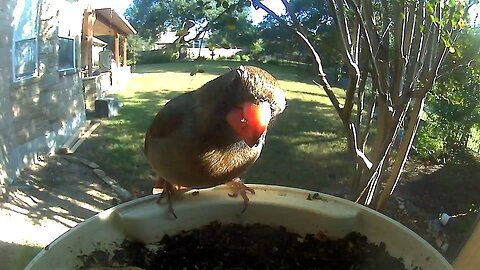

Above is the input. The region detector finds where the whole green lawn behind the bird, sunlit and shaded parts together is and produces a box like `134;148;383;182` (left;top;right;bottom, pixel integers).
78;61;353;193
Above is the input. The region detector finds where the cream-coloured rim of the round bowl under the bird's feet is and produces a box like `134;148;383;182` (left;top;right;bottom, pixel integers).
26;185;452;270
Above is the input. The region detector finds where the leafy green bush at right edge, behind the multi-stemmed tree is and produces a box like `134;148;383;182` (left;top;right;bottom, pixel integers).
417;29;480;157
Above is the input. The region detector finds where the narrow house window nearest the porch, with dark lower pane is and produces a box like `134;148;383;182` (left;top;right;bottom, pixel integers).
58;1;78;71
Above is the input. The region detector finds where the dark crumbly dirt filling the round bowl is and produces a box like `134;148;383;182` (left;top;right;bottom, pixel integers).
79;222;420;270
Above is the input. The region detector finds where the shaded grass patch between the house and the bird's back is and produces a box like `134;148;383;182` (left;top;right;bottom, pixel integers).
76;90;182;196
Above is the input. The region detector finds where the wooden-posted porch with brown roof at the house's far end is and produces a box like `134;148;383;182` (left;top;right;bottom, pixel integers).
81;8;137;110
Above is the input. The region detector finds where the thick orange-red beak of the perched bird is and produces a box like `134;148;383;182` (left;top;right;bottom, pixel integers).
226;102;272;147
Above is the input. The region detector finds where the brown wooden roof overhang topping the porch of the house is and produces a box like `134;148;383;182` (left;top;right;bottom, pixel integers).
93;8;137;36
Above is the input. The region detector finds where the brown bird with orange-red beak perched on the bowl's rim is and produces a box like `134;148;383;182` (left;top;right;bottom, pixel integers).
144;65;287;218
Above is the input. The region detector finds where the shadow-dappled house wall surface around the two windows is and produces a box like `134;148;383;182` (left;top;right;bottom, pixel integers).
0;0;85;190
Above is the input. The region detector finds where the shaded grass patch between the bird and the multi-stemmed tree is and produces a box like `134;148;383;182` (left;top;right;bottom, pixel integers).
245;99;352;191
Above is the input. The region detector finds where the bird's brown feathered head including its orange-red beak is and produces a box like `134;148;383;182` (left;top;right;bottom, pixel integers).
226;66;287;147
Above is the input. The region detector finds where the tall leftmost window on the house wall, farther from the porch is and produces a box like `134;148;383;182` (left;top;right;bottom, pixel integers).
12;0;40;81
